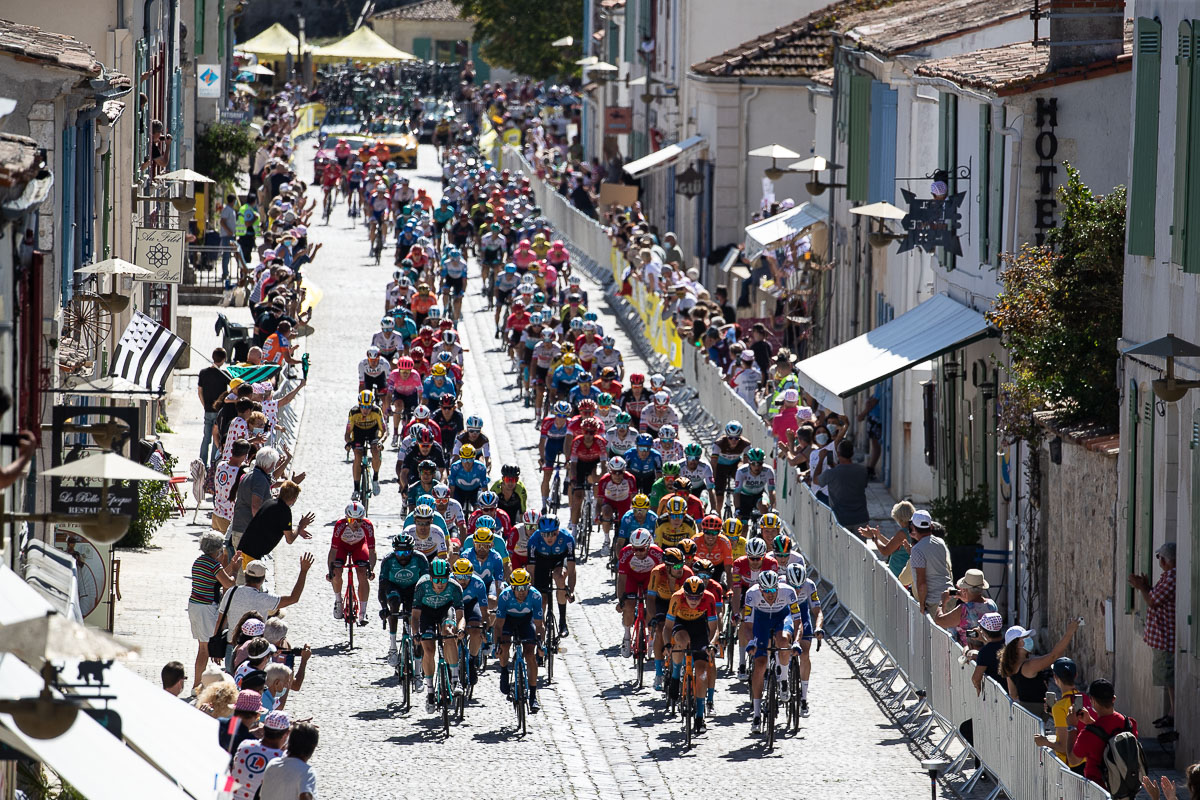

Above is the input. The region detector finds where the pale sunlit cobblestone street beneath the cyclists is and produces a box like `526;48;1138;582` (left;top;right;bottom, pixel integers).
116;145;945;800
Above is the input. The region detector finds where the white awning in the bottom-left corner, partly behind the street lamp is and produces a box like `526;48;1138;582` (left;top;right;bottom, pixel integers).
0;652;190;800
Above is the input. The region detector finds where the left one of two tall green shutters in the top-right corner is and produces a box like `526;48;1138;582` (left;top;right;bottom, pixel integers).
1128;17;1163;255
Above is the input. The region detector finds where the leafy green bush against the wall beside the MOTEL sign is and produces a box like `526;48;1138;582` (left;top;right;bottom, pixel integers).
988;164;1126;441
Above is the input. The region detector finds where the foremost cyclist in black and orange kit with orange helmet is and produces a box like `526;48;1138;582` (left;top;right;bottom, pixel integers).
665;575;721;734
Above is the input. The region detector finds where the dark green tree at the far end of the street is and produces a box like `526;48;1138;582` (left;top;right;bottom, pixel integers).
455;0;583;79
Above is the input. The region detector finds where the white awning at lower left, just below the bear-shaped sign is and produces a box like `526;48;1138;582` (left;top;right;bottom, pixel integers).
64;662;229;798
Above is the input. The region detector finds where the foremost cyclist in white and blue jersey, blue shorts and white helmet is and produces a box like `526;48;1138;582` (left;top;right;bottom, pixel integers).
742;573;800;733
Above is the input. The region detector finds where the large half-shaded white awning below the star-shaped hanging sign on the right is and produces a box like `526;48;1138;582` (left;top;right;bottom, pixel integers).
796;294;991;414
